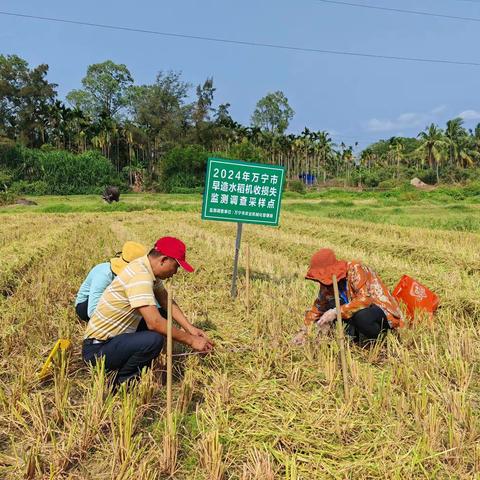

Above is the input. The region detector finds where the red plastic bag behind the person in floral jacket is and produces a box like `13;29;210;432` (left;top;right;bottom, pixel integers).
393;275;440;321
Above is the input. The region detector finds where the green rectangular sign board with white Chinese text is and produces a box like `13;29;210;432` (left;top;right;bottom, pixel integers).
202;158;285;225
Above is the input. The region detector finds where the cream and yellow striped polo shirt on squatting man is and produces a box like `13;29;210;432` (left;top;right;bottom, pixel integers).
84;255;162;340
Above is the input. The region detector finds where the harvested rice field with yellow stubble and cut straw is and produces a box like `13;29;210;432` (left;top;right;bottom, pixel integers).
0;196;480;480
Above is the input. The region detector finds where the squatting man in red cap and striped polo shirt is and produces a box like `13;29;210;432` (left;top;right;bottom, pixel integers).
82;237;213;384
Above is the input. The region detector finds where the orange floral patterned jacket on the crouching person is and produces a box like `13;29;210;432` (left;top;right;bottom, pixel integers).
305;262;403;328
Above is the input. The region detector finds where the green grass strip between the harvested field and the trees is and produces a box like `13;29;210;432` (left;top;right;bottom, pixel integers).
0;187;480;232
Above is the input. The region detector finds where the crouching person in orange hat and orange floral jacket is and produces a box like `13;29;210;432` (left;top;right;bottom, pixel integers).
293;248;403;345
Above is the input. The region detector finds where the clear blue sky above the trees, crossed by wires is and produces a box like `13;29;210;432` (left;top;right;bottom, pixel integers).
0;0;480;147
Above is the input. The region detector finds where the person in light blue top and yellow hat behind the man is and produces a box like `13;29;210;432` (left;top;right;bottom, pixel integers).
75;242;147;322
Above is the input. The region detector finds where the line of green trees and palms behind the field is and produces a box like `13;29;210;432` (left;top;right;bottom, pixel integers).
0;55;480;193
